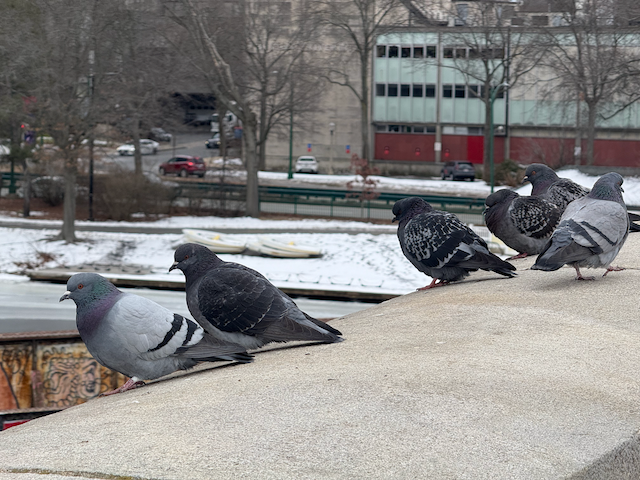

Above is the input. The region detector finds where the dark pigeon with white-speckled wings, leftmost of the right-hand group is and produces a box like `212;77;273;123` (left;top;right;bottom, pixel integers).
393;197;516;290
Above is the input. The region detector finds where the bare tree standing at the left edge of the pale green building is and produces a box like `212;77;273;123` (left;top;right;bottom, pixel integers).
313;0;403;159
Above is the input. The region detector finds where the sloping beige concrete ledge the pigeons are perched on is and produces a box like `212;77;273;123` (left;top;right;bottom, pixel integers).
0;234;640;479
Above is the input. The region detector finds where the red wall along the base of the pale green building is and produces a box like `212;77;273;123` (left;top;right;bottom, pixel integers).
374;133;640;168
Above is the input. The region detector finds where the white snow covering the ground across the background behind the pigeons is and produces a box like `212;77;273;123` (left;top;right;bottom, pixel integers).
0;170;640;294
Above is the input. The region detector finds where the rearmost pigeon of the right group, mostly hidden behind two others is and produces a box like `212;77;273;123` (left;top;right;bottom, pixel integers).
522;163;640;232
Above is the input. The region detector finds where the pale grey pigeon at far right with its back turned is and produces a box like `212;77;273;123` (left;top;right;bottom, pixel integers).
531;172;629;280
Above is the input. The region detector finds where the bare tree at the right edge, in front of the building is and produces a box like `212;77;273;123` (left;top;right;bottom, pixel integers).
540;0;640;165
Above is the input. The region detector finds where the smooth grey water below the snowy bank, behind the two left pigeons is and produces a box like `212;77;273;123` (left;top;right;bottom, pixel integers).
0;281;374;333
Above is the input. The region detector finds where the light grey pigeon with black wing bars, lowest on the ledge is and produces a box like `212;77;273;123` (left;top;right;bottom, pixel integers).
60;273;252;395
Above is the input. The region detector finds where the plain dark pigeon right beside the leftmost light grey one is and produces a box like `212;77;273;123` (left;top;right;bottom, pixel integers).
169;243;343;349
